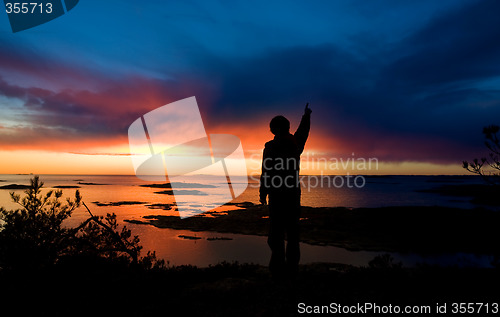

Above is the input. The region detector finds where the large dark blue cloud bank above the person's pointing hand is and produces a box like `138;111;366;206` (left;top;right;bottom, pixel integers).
188;1;500;162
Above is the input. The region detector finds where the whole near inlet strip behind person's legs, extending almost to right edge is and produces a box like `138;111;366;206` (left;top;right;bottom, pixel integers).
130;224;491;267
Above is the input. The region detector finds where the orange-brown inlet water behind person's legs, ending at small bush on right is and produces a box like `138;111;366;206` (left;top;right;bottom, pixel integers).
129;224;378;266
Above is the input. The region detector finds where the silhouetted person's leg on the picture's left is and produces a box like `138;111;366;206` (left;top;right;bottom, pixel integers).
267;197;286;278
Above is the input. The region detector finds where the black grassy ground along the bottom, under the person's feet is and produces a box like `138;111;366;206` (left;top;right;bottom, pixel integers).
0;258;500;317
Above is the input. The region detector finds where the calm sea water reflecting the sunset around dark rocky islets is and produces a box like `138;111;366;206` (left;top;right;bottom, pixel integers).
0;175;489;266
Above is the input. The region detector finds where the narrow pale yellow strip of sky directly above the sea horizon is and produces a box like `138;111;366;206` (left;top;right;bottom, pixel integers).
0;151;467;175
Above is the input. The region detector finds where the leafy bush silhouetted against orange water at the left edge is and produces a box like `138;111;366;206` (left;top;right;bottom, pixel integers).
0;176;164;269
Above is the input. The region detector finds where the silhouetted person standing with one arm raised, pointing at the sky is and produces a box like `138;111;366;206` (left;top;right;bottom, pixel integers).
260;104;312;279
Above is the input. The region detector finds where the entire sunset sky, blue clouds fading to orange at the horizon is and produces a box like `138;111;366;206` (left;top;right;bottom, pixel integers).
0;0;500;174
